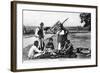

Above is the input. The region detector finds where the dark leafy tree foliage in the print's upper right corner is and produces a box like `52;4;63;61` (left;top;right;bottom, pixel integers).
80;13;91;31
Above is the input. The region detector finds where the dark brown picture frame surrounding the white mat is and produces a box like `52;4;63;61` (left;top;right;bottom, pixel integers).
11;1;98;72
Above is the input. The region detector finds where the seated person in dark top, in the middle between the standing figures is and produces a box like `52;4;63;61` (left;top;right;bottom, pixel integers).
45;38;55;55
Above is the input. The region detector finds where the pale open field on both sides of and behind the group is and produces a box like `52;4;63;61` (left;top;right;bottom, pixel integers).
23;32;91;60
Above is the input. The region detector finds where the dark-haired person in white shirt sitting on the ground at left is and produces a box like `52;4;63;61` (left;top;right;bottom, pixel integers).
28;41;42;59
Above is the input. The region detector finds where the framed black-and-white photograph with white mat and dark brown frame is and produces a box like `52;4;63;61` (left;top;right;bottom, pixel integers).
11;1;97;71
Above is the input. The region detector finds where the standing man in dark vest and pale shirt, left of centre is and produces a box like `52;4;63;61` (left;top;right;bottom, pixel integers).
38;22;45;51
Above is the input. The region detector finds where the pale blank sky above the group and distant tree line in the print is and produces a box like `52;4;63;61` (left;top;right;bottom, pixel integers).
23;10;84;27
